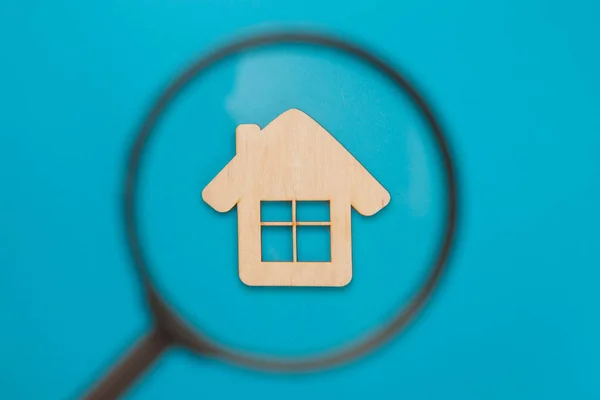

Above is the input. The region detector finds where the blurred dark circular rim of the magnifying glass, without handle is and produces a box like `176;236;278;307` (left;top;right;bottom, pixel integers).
123;32;458;372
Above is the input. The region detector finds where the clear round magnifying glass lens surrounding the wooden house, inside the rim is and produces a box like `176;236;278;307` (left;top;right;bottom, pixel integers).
137;46;447;357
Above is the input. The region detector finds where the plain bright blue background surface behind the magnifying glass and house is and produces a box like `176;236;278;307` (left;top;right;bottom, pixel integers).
0;0;600;400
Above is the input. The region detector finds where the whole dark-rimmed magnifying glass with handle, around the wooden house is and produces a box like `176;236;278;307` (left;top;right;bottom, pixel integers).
83;32;458;399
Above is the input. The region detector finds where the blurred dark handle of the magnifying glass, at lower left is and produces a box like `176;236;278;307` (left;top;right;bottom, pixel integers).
82;329;172;400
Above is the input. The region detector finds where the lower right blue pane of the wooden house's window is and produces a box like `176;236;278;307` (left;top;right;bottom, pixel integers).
296;226;331;262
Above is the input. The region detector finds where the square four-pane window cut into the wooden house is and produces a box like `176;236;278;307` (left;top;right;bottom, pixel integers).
260;200;331;262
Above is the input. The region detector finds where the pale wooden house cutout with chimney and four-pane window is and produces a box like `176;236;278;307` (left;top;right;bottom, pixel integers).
202;109;390;286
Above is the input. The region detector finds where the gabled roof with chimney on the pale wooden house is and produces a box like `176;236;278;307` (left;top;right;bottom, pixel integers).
202;109;390;215
